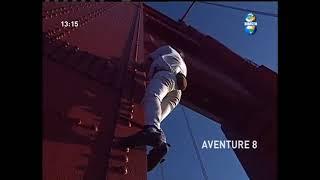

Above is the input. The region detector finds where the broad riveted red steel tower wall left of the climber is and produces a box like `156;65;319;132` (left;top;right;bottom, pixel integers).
43;2;146;180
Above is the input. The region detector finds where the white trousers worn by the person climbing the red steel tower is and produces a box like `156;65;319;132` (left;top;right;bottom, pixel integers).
143;71;181;129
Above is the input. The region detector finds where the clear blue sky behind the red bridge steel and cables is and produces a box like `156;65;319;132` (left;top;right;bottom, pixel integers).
147;2;278;180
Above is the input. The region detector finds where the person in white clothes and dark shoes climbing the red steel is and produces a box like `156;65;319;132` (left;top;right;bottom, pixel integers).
115;42;187;171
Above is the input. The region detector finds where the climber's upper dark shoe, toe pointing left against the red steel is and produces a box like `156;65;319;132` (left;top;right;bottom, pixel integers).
118;126;165;148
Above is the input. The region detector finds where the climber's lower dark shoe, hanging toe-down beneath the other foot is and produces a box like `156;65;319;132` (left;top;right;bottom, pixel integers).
147;143;170;172
